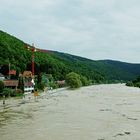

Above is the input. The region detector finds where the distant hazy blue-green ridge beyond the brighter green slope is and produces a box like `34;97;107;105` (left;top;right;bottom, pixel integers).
52;52;140;80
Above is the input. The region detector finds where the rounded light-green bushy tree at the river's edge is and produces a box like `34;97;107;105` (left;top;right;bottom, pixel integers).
66;72;82;88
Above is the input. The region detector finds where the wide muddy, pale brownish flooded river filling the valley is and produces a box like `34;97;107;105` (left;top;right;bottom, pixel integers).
0;84;140;140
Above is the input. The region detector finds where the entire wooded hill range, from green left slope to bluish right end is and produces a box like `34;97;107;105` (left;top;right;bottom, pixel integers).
0;31;140;83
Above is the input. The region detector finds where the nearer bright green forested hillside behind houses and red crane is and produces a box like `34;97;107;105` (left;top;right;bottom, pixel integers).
0;31;104;82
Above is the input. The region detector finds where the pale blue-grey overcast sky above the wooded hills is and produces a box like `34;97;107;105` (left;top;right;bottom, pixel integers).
0;0;140;63
